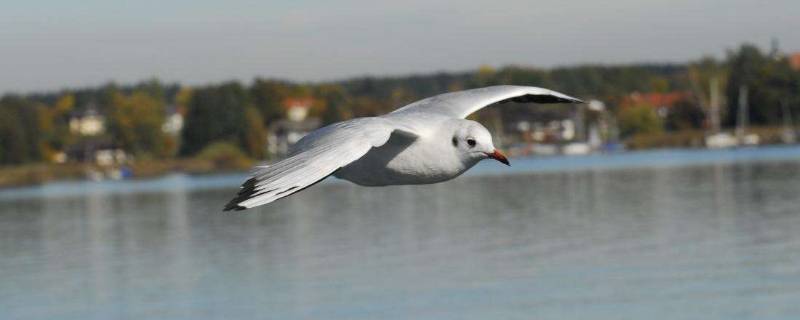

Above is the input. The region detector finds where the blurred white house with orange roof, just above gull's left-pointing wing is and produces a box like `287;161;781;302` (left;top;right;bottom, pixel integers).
267;98;322;155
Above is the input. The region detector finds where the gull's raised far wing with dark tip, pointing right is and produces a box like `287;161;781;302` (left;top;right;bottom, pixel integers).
392;86;583;118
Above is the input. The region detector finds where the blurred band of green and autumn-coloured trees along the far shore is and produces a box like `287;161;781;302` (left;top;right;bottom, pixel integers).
0;45;800;164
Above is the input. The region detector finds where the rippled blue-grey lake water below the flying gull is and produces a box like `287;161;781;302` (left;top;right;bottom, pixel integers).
0;147;800;320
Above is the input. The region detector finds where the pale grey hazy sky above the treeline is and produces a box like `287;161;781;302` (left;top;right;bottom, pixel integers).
0;0;800;93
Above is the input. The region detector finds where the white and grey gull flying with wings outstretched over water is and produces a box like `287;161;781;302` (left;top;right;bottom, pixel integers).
224;85;583;211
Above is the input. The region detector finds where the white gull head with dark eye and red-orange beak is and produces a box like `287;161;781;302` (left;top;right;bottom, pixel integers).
450;120;511;166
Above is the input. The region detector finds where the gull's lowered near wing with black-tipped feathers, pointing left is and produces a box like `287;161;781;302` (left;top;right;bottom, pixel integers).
224;118;413;211
